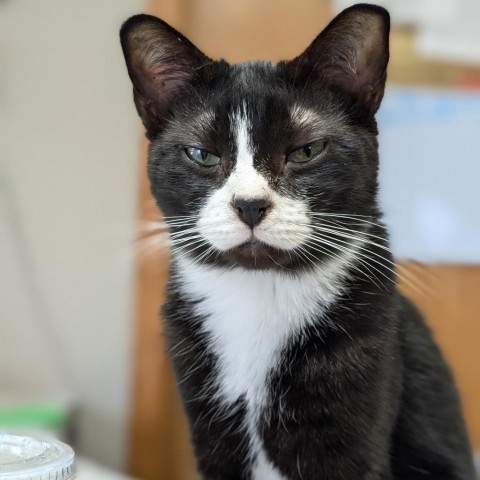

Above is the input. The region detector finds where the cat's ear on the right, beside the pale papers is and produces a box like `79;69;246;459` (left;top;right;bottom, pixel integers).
286;4;390;116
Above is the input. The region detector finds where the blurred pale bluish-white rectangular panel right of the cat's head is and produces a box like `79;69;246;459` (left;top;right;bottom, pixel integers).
377;87;480;264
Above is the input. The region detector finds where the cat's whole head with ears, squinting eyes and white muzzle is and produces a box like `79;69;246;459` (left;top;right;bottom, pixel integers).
121;5;389;269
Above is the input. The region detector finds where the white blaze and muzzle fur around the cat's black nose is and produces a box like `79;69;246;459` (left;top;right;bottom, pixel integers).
197;107;311;251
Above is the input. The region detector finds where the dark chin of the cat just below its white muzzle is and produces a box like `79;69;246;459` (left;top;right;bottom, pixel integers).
226;238;291;270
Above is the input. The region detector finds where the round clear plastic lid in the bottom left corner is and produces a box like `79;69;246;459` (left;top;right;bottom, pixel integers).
0;432;75;480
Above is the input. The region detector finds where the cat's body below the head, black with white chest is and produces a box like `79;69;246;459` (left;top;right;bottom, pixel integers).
165;263;473;480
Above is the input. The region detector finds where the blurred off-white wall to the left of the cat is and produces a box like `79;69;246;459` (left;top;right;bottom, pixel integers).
0;0;145;468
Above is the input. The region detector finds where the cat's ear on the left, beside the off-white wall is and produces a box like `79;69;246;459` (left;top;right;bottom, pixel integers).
120;15;212;140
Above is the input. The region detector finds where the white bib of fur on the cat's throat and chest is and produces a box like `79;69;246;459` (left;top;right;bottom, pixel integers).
177;249;355;480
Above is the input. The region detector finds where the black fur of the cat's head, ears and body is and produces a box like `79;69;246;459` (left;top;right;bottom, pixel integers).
121;5;474;480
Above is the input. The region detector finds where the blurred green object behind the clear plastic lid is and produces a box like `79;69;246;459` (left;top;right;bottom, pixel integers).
0;404;67;428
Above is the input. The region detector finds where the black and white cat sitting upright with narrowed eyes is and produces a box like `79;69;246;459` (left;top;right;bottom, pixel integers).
121;5;474;480
